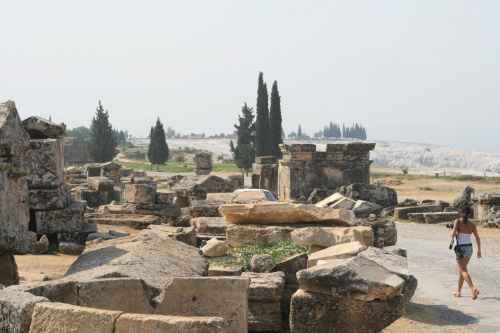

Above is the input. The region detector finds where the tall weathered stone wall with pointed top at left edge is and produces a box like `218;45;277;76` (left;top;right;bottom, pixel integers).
0;101;36;262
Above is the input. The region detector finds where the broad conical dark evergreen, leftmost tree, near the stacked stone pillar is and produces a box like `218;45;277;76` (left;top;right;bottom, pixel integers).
87;101;117;163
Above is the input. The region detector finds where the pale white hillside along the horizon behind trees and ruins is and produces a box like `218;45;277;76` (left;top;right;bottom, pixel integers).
130;139;500;173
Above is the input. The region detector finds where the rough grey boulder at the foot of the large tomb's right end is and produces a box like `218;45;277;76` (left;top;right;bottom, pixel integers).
339;183;398;208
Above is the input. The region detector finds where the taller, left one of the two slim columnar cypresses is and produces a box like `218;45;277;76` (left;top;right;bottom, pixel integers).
255;72;270;156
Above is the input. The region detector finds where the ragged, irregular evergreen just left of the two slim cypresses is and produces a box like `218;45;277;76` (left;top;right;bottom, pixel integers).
229;103;256;176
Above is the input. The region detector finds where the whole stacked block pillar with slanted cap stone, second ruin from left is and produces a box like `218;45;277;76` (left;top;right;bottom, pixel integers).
23;117;85;245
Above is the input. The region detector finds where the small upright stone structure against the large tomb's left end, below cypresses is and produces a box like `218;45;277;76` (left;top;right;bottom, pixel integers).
252;156;279;198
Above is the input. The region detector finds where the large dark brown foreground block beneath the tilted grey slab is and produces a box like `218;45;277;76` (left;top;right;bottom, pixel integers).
290;276;417;333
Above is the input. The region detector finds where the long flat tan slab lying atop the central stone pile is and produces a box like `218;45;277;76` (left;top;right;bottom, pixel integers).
219;202;353;226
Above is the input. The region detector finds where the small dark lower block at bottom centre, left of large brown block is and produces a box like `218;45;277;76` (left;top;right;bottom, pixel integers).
248;302;282;332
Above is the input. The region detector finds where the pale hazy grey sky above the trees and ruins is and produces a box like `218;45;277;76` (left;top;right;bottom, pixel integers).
0;0;500;152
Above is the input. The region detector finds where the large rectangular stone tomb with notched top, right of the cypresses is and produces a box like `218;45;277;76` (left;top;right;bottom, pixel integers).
278;142;375;201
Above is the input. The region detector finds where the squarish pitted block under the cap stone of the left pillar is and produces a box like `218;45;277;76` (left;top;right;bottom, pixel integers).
25;139;64;189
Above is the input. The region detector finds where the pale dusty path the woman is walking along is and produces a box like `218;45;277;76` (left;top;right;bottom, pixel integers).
384;223;500;333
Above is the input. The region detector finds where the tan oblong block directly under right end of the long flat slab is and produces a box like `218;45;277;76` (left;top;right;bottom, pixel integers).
292;227;373;247
